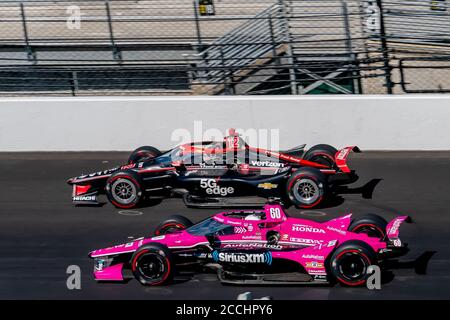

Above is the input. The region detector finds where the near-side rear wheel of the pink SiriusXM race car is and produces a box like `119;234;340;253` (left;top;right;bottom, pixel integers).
329;240;377;287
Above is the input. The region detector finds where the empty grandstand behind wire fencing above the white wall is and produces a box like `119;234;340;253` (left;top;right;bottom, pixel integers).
0;0;450;95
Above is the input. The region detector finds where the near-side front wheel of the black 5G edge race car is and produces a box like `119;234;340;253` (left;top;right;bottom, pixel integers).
105;170;143;209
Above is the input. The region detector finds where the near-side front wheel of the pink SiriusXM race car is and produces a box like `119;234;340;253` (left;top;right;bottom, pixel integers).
130;243;174;286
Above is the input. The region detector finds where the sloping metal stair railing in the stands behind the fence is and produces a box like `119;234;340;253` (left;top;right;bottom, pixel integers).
185;3;288;93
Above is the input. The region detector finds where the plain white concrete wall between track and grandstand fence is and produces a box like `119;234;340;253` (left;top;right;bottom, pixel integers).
0;95;450;151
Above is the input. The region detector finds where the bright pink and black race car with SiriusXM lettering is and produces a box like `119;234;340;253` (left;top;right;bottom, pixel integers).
89;201;409;286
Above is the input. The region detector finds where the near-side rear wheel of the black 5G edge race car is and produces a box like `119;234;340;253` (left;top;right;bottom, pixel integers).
286;167;328;209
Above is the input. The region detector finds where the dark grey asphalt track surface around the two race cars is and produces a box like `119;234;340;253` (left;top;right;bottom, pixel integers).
0;152;450;300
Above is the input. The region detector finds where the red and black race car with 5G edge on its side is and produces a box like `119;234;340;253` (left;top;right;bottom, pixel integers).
68;131;360;209
